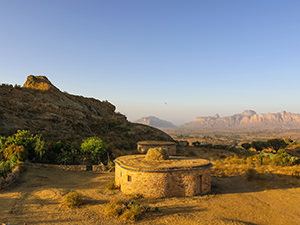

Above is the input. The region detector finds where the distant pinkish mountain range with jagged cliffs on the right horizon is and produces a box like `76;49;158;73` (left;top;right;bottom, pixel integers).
181;110;300;129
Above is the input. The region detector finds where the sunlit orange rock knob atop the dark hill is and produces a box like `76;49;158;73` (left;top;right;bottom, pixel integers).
23;75;58;91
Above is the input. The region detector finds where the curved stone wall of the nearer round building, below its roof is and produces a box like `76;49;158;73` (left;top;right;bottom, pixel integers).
115;163;211;198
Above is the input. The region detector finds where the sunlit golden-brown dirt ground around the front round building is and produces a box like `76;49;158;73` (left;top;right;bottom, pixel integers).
0;160;300;225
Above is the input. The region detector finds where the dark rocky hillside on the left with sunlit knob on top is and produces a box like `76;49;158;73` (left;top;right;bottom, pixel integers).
0;76;172;149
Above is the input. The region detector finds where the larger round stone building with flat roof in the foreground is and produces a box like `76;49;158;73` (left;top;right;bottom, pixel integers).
115;155;212;198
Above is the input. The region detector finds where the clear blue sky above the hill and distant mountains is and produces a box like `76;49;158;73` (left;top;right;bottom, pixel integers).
0;0;300;125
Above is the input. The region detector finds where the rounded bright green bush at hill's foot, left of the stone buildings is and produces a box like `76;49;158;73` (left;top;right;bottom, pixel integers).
81;137;106;163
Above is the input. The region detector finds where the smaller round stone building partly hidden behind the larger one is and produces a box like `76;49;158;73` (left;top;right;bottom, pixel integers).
137;141;176;155
